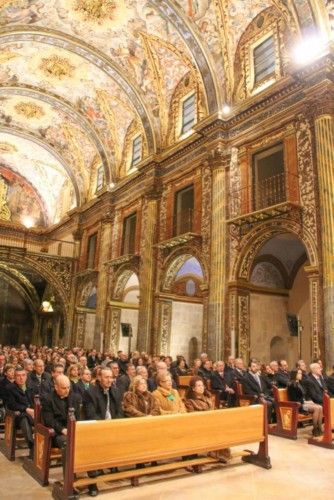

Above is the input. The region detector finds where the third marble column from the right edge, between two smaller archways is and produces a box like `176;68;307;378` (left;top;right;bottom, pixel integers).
137;197;158;352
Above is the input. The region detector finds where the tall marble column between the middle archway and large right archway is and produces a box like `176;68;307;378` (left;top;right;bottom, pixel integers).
207;145;230;360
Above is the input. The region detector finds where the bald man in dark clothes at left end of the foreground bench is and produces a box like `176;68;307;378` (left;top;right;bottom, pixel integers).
41;375;81;471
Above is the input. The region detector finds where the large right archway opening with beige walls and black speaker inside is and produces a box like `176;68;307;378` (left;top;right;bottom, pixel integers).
249;233;312;366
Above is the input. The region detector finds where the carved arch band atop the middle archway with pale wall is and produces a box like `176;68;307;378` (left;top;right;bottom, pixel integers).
159;248;208;292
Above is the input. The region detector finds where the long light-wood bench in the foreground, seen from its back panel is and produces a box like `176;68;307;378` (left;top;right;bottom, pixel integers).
52;403;271;500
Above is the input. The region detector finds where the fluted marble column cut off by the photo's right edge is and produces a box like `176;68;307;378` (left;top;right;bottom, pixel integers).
315;113;334;368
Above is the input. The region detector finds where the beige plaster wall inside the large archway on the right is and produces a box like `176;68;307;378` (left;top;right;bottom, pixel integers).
250;293;298;367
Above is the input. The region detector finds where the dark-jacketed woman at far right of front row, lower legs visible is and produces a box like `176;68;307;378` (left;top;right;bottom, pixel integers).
288;369;323;437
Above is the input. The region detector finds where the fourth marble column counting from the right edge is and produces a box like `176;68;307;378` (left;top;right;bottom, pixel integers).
94;218;112;350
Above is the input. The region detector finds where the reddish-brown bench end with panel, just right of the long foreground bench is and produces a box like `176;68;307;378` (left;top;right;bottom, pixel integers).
269;386;312;439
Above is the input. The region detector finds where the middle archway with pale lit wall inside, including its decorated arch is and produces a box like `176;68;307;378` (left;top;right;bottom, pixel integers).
159;255;204;361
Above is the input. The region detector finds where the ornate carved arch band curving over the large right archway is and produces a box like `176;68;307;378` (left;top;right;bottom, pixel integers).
231;220;319;281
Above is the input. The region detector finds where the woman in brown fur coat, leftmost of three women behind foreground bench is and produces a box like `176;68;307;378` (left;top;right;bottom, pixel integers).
122;375;160;417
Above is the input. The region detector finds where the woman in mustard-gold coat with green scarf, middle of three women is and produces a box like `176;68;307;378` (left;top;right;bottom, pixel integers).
152;372;186;415
